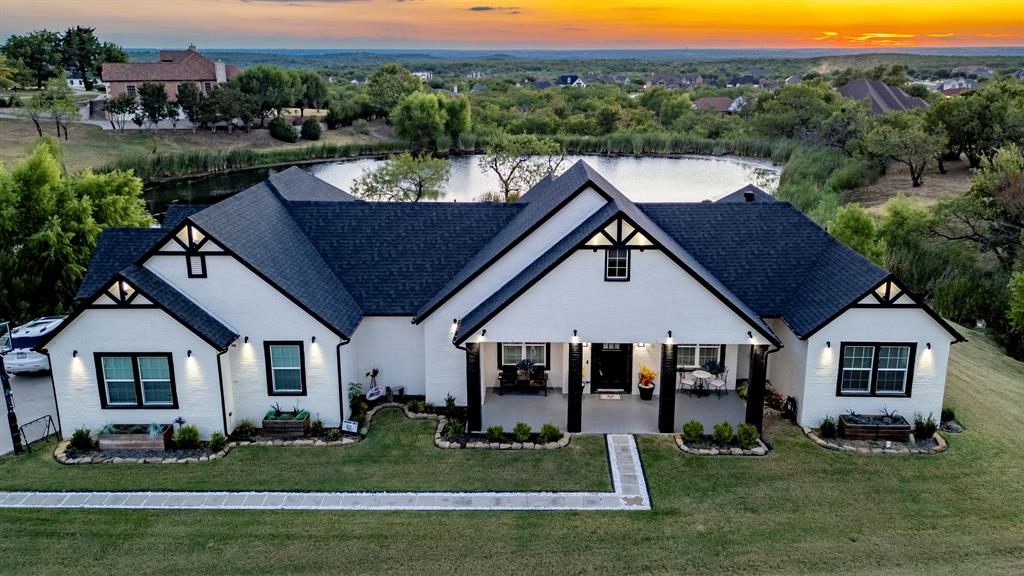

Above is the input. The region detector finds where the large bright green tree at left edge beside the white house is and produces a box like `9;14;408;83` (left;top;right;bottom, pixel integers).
0;138;153;322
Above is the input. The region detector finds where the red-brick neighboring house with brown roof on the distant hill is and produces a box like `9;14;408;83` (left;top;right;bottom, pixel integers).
100;44;241;100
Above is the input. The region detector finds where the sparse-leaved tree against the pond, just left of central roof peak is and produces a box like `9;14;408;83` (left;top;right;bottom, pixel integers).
479;134;565;202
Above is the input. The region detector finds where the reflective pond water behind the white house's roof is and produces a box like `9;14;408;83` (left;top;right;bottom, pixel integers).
144;156;780;213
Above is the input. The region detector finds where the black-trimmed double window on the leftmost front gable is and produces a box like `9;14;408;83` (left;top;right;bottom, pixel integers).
95;353;178;408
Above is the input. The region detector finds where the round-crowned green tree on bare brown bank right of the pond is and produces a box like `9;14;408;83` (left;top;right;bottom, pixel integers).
861;112;948;188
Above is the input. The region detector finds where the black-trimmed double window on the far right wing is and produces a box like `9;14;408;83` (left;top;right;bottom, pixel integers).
836;342;918;397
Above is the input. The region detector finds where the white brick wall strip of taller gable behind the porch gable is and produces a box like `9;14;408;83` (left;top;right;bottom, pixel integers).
421;190;607;406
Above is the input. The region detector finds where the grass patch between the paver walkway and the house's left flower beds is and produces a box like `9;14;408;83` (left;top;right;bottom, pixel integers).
0;410;611;491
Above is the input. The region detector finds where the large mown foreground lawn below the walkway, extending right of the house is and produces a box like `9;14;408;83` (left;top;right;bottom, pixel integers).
0;331;1024;575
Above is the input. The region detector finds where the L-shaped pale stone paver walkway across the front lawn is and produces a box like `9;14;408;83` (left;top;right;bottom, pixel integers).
0;435;650;511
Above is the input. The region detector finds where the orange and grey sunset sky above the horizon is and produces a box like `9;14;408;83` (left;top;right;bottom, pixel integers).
0;0;1024;49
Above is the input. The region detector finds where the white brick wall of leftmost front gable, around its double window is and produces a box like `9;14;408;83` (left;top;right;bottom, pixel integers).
46;307;224;438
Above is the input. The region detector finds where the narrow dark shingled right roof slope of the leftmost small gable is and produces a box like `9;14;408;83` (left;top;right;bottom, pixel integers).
120;266;239;351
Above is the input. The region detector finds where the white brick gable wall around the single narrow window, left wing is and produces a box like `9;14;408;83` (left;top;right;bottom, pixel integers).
145;255;348;426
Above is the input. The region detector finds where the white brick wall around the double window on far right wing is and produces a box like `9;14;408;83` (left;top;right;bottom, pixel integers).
798;306;952;426
